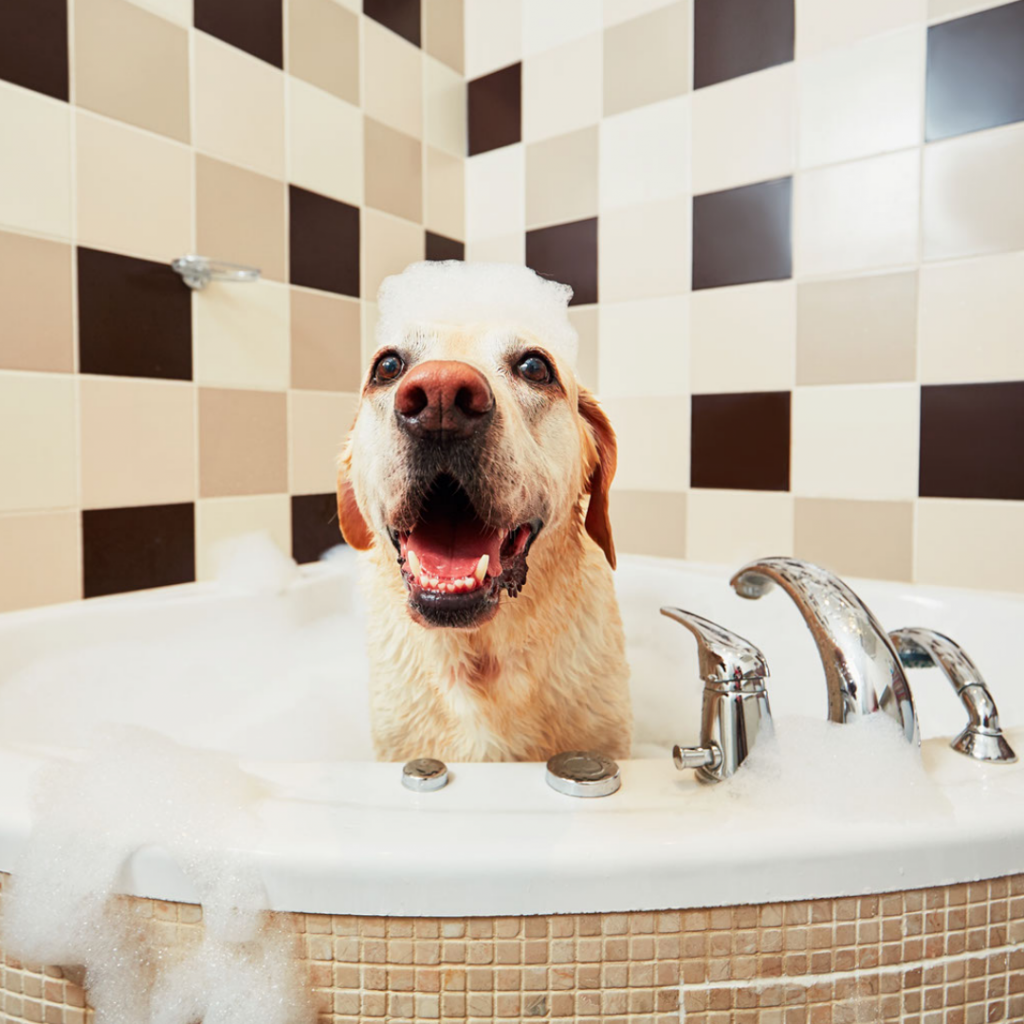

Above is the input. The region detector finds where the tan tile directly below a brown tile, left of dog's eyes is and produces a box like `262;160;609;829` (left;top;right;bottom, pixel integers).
292;288;362;391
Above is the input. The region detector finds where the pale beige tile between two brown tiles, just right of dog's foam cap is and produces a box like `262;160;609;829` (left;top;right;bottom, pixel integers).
598;197;690;302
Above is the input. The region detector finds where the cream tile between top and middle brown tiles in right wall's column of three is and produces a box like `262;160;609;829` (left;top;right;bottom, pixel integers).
691;63;797;195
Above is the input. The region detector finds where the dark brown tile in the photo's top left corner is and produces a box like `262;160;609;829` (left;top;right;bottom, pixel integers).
0;0;68;99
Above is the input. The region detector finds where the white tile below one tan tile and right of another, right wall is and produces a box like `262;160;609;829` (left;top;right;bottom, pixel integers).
601;96;690;211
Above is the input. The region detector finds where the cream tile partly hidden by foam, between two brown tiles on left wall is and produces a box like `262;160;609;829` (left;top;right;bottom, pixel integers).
196;495;292;580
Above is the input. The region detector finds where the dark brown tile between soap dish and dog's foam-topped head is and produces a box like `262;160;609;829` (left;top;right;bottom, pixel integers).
288;185;359;297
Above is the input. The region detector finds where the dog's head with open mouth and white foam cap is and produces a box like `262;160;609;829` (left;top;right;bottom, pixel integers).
338;262;615;629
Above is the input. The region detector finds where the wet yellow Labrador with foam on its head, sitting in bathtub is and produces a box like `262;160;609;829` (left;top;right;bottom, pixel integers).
338;261;632;761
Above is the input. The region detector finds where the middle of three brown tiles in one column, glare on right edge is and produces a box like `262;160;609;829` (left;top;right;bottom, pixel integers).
693;178;793;290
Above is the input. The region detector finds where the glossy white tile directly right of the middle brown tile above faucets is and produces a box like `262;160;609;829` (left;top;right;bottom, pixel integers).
795;150;920;275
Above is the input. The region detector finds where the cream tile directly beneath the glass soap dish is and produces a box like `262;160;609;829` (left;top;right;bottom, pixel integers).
193;280;290;390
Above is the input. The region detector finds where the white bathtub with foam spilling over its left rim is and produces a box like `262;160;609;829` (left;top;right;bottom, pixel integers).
0;557;1024;916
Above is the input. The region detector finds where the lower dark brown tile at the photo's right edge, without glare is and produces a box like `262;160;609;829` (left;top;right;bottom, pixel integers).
920;381;1024;501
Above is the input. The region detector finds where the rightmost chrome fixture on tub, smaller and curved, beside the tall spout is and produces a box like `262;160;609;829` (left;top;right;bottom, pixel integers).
889;627;1017;764
